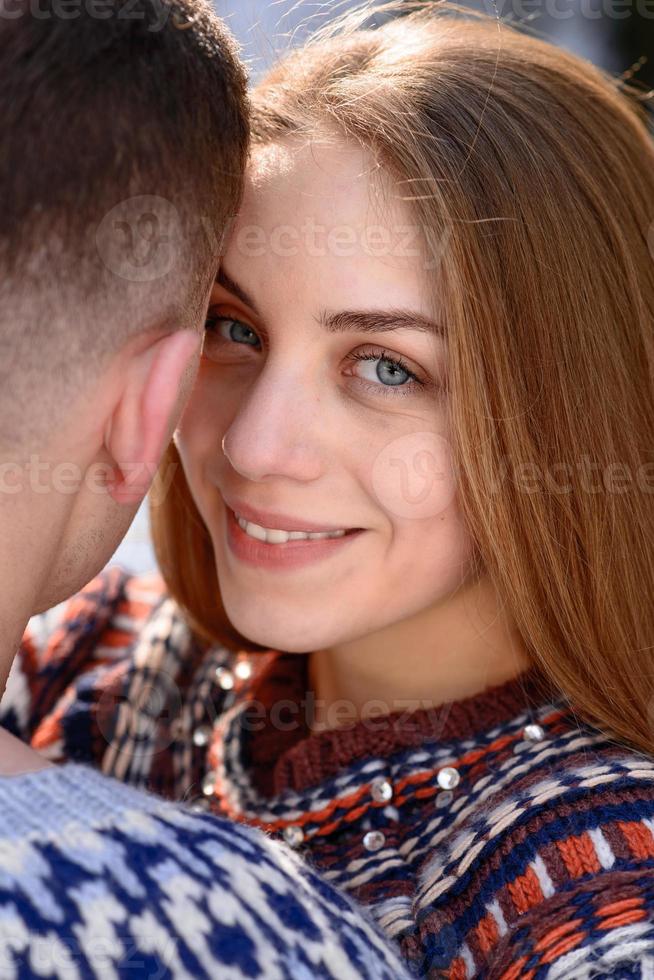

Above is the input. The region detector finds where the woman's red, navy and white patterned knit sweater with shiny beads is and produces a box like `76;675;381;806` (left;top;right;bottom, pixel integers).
0;570;654;980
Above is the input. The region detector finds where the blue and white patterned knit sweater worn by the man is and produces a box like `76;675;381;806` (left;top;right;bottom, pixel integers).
0;763;410;980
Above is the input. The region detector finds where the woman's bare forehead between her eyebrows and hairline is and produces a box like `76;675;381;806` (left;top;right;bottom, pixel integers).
225;136;440;315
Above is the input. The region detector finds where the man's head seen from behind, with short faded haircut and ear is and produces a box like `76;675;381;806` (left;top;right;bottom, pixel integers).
0;0;248;608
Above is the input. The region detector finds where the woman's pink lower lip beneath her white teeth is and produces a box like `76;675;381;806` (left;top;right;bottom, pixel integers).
225;506;363;569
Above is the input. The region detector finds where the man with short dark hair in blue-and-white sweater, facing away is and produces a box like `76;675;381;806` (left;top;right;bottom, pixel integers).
0;0;410;980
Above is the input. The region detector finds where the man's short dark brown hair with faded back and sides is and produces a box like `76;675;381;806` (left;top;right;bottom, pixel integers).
0;0;249;444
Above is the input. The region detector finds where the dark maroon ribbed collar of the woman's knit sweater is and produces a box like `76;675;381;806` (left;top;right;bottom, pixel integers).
211;651;561;813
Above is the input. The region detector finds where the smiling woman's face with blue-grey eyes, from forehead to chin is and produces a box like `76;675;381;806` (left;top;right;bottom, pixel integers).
176;140;480;652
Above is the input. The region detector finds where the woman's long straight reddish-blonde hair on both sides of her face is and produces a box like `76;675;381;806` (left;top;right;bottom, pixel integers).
152;3;654;752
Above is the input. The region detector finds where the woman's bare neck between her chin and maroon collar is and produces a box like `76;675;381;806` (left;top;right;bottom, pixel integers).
308;577;531;731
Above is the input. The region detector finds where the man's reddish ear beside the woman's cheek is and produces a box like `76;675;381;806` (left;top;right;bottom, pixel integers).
104;330;202;504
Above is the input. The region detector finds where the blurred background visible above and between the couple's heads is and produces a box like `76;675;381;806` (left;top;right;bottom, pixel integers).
114;0;654;573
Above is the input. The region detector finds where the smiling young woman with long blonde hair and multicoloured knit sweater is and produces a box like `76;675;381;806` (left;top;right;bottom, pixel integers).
5;3;654;980
